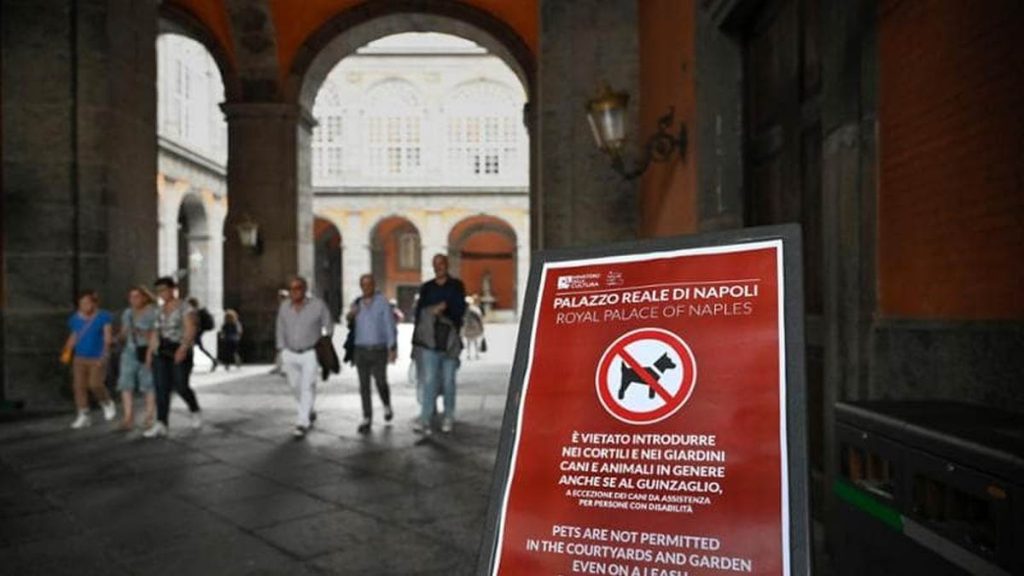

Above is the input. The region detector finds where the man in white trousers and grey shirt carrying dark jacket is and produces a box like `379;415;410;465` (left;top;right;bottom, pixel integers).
276;276;334;438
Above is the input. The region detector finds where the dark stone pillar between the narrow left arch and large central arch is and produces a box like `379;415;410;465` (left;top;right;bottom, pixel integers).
223;102;312;362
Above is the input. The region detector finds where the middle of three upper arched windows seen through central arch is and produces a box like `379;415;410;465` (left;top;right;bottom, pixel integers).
366;80;423;177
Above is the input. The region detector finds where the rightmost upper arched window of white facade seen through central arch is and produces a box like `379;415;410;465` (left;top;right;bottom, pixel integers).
446;81;526;180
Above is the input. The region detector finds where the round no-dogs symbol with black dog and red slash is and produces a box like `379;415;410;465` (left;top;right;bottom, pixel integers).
595;328;697;424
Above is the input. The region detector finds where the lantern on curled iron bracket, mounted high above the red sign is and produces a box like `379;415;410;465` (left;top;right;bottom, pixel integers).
587;84;686;180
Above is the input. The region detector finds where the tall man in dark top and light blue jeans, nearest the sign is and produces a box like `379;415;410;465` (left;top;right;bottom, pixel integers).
413;254;466;435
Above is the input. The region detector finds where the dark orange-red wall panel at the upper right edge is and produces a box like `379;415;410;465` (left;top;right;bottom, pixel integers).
878;0;1024;320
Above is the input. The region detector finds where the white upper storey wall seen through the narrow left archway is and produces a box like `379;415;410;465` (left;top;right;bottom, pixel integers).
157;34;227;164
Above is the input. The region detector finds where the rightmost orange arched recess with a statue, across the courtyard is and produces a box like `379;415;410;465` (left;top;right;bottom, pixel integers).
449;214;520;315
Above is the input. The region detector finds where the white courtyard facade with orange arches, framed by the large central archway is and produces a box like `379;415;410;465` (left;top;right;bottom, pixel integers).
311;33;529;318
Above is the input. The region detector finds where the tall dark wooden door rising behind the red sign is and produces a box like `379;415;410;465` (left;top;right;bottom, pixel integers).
743;0;824;495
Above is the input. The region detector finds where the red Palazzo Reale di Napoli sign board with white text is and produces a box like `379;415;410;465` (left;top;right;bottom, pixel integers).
486;230;806;576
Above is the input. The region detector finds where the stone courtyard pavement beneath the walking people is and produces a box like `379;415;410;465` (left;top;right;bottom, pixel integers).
0;325;516;576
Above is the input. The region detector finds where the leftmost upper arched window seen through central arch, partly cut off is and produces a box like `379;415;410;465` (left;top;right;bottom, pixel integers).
312;74;351;186
